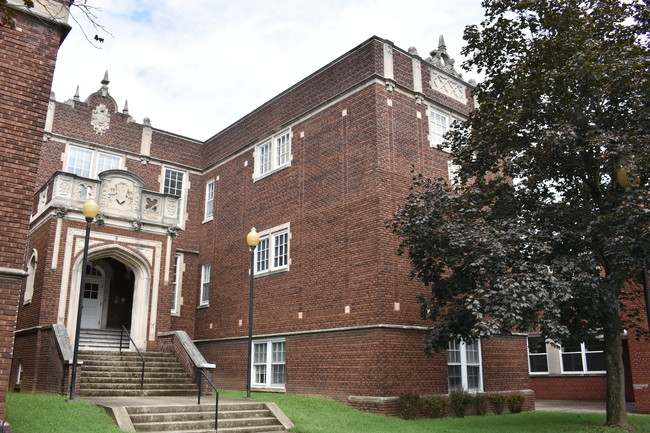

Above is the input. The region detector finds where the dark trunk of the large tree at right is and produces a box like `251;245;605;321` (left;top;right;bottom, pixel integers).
603;311;629;427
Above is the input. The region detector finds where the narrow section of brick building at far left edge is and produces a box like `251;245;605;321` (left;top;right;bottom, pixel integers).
0;0;70;431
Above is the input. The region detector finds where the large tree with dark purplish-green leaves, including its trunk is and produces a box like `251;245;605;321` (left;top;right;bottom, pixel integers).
389;0;650;426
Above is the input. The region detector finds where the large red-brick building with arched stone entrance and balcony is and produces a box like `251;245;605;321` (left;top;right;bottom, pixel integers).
11;33;648;413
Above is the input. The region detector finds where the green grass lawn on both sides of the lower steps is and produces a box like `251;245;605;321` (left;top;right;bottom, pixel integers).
7;391;650;433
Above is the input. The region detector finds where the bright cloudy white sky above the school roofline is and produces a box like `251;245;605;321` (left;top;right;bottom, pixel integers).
52;0;483;140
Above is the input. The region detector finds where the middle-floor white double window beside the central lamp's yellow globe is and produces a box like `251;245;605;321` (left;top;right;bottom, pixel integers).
255;224;290;275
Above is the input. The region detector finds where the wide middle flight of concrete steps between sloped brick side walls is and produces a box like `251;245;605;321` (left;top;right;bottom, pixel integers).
79;350;198;397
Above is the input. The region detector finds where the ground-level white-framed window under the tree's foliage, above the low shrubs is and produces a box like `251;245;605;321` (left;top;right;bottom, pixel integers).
447;340;483;392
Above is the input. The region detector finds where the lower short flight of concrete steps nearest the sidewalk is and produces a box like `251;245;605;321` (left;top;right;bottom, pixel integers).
126;403;285;433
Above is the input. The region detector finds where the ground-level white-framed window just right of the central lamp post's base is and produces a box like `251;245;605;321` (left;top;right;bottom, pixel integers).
251;339;287;388
